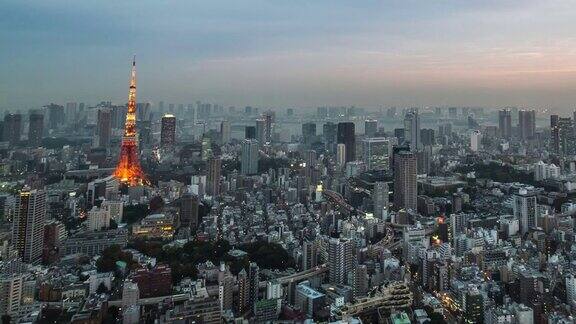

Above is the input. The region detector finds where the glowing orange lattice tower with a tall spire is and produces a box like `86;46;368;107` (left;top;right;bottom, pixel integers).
114;57;149;186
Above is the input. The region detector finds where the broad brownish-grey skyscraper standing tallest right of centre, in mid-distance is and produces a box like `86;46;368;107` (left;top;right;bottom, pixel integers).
394;151;418;210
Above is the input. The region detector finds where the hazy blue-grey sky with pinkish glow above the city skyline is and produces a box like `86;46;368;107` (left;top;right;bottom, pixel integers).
0;0;576;111
